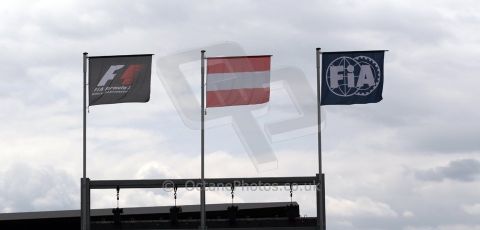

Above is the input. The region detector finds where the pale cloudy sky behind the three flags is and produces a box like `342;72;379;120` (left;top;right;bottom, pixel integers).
0;0;480;230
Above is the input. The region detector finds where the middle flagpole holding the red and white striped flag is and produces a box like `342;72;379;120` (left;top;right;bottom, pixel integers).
200;50;206;229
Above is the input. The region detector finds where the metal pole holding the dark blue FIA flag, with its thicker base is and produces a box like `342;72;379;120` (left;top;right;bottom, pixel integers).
316;48;326;230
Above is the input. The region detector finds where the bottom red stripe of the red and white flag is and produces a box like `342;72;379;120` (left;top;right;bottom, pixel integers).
207;88;270;107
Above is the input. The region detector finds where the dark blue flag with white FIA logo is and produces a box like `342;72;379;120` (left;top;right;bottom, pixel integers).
321;50;385;105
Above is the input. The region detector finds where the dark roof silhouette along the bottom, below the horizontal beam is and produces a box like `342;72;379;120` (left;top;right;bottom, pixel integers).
0;202;316;230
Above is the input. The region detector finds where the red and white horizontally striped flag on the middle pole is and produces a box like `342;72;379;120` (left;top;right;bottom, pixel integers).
207;55;271;107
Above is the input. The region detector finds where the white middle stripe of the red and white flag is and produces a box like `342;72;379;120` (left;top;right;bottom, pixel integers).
207;71;270;91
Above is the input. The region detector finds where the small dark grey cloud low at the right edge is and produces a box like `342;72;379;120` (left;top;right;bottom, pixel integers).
415;159;480;182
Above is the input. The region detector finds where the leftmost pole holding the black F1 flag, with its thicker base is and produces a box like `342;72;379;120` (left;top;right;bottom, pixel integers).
80;52;89;230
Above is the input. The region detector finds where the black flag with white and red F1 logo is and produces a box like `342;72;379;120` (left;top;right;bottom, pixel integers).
88;54;152;105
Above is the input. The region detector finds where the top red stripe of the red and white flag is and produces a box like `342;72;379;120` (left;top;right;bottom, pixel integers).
207;56;271;74
